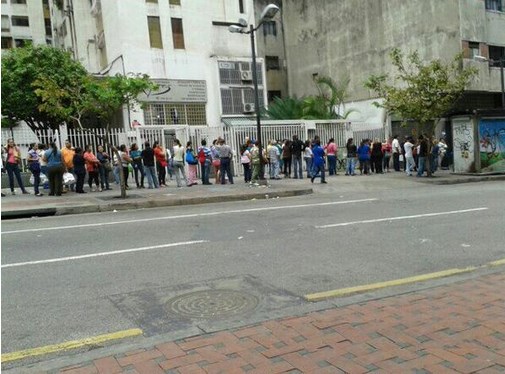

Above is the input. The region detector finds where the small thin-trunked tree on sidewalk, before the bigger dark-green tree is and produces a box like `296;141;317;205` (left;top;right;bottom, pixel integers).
34;74;156;198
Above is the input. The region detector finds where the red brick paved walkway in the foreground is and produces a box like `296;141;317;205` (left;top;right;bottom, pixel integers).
58;272;505;374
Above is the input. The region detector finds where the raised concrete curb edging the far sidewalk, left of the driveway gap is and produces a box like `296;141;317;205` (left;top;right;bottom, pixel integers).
2;188;314;219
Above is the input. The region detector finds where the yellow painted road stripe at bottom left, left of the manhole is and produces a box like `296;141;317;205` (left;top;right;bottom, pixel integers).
1;329;143;363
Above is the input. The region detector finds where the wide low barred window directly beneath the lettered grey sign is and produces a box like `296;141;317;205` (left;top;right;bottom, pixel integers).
144;103;207;126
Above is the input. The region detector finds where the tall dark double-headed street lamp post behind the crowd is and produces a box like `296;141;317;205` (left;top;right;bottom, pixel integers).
228;4;280;180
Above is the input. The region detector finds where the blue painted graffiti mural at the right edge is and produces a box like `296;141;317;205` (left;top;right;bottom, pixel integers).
479;119;505;173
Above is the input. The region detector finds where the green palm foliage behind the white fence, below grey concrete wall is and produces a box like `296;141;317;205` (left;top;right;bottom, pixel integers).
263;77;350;120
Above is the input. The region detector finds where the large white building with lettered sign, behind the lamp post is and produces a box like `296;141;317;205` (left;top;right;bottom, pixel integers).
48;0;267;127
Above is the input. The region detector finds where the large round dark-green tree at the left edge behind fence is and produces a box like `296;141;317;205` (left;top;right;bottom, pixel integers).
2;45;88;130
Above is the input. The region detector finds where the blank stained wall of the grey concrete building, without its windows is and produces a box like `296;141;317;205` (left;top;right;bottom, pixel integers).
283;0;462;100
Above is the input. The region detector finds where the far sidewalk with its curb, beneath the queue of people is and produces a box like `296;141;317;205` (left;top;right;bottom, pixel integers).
1;170;505;219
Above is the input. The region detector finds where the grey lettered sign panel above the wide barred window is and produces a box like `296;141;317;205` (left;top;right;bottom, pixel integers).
139;79;207;103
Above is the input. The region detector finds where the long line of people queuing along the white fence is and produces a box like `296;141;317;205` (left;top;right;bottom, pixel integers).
2;135;448;196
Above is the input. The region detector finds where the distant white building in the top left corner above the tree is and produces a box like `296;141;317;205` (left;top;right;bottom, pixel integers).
2;0;52;51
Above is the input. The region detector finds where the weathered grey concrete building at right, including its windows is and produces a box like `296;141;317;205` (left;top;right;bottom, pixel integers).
283;0;505;134
